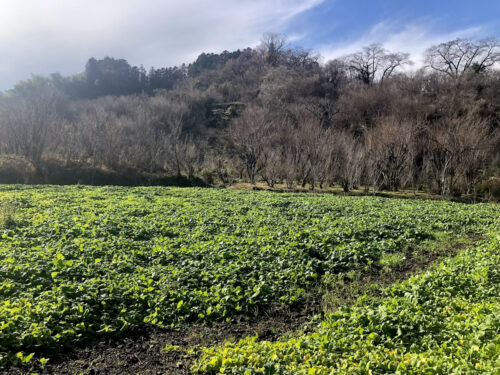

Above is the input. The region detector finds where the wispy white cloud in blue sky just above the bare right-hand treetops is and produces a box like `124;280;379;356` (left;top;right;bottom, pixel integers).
318;20;482;68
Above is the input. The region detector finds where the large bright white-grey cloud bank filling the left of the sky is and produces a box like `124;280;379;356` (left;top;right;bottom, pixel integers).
0;0;324;89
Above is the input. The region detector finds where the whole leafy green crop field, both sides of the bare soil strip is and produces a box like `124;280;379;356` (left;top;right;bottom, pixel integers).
0;186;500;374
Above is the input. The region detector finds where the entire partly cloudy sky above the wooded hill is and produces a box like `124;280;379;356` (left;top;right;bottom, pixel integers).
0;0;500;90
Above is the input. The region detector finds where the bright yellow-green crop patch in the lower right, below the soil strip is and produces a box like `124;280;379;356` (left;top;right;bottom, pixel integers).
193;235;500;375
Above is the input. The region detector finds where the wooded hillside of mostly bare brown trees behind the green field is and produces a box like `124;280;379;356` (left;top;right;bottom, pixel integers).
0;34;500;200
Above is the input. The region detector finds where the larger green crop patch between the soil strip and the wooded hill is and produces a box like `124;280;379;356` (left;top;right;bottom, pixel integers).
0;186;500;364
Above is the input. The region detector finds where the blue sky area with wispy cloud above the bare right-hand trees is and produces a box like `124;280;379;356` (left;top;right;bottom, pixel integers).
285;0;500;62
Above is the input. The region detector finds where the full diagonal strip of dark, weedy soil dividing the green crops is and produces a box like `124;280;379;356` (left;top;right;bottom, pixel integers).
0;236;471;375
